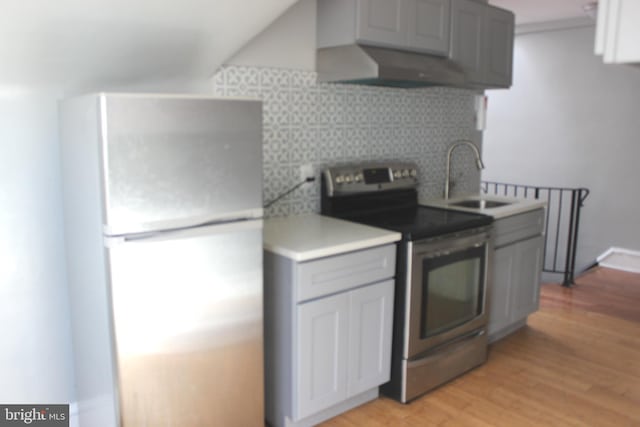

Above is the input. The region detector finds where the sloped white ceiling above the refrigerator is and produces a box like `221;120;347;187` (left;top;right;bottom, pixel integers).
0;0;297;91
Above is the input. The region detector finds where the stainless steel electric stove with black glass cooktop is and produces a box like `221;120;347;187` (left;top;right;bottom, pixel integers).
322;162;493;403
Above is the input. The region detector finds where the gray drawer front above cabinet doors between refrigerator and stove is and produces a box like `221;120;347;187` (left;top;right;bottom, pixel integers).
296;245;396;302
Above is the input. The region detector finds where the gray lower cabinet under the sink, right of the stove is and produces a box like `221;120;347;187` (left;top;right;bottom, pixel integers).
488;209;544;342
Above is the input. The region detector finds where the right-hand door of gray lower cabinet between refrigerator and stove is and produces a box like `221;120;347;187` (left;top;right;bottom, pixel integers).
348;280;394;396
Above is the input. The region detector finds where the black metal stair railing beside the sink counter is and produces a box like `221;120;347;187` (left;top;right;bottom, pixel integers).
481;181;589;286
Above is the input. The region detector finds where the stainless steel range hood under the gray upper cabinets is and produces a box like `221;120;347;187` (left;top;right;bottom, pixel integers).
316;44;468;88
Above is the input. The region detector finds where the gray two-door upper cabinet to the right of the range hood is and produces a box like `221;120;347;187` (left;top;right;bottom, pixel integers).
449;0;515;87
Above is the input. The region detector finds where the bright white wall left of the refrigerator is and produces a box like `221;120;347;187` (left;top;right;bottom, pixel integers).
0;87;73;403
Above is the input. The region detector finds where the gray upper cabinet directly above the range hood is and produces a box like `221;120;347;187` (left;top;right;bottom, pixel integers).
318;0;451;56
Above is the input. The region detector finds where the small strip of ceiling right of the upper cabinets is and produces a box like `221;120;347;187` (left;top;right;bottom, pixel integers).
489;0;594;25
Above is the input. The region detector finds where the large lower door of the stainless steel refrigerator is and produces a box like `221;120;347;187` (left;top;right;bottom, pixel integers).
107;220;264;427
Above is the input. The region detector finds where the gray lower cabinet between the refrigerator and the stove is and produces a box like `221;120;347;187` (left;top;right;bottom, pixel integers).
265;245;395;427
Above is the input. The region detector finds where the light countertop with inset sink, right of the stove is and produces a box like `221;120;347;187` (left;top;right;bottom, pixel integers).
420;194;547;219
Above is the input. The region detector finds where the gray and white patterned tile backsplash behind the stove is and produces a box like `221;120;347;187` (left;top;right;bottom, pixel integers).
213;66;480;216
